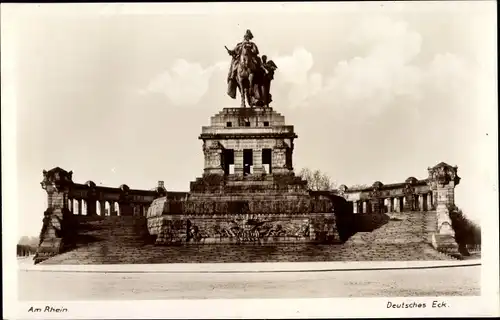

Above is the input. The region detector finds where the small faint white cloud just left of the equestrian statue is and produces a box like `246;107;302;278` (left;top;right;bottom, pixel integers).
140;59;229;106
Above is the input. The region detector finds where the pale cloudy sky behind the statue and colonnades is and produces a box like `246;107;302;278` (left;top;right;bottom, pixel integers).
2;1;498;236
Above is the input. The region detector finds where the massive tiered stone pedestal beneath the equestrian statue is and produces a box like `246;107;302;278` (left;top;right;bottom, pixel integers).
147;108;352;244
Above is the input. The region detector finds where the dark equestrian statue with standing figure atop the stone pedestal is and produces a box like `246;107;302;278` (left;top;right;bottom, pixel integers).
225;30;278;108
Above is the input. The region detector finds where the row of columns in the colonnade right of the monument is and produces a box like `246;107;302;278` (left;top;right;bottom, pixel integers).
352;191;435;213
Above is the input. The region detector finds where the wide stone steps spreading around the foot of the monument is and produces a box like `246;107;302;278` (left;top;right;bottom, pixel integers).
41;212;464;264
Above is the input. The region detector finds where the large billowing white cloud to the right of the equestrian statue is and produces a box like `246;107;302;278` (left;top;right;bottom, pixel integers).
275;17;471;121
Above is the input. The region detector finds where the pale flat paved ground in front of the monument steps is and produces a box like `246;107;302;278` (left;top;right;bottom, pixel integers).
18;266;481;301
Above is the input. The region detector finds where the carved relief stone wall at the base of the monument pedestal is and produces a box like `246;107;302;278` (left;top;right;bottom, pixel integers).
148;213;340;245
